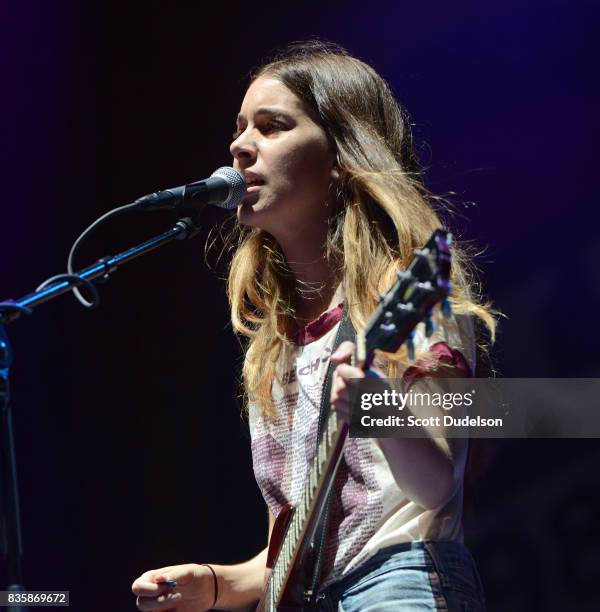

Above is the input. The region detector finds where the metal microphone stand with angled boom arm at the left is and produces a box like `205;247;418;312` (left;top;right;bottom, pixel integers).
0;217;206;612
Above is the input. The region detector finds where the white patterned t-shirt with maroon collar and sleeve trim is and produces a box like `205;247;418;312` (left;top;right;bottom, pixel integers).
249;305;475;586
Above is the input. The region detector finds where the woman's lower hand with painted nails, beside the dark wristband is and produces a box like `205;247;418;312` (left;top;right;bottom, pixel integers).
131;563;215;612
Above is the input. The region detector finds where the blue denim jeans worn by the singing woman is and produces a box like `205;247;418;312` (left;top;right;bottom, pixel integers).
317;542;485;612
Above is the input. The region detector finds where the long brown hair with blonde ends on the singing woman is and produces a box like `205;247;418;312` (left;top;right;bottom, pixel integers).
227;41;495;415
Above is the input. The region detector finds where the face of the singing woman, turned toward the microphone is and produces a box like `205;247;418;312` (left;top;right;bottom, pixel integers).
231;75;335;238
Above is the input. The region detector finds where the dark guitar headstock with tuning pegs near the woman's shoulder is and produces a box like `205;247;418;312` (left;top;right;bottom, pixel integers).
357;230;451;368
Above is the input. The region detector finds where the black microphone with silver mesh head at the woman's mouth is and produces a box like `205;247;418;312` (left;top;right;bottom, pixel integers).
134;166;246;214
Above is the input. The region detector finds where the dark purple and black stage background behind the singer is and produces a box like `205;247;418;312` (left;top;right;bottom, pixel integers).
0;0;600;612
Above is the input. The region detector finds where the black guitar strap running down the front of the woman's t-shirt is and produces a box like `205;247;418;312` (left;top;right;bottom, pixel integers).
305;302;356;605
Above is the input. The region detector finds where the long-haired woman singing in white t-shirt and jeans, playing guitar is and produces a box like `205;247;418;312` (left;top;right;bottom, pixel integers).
132;42;494;612
